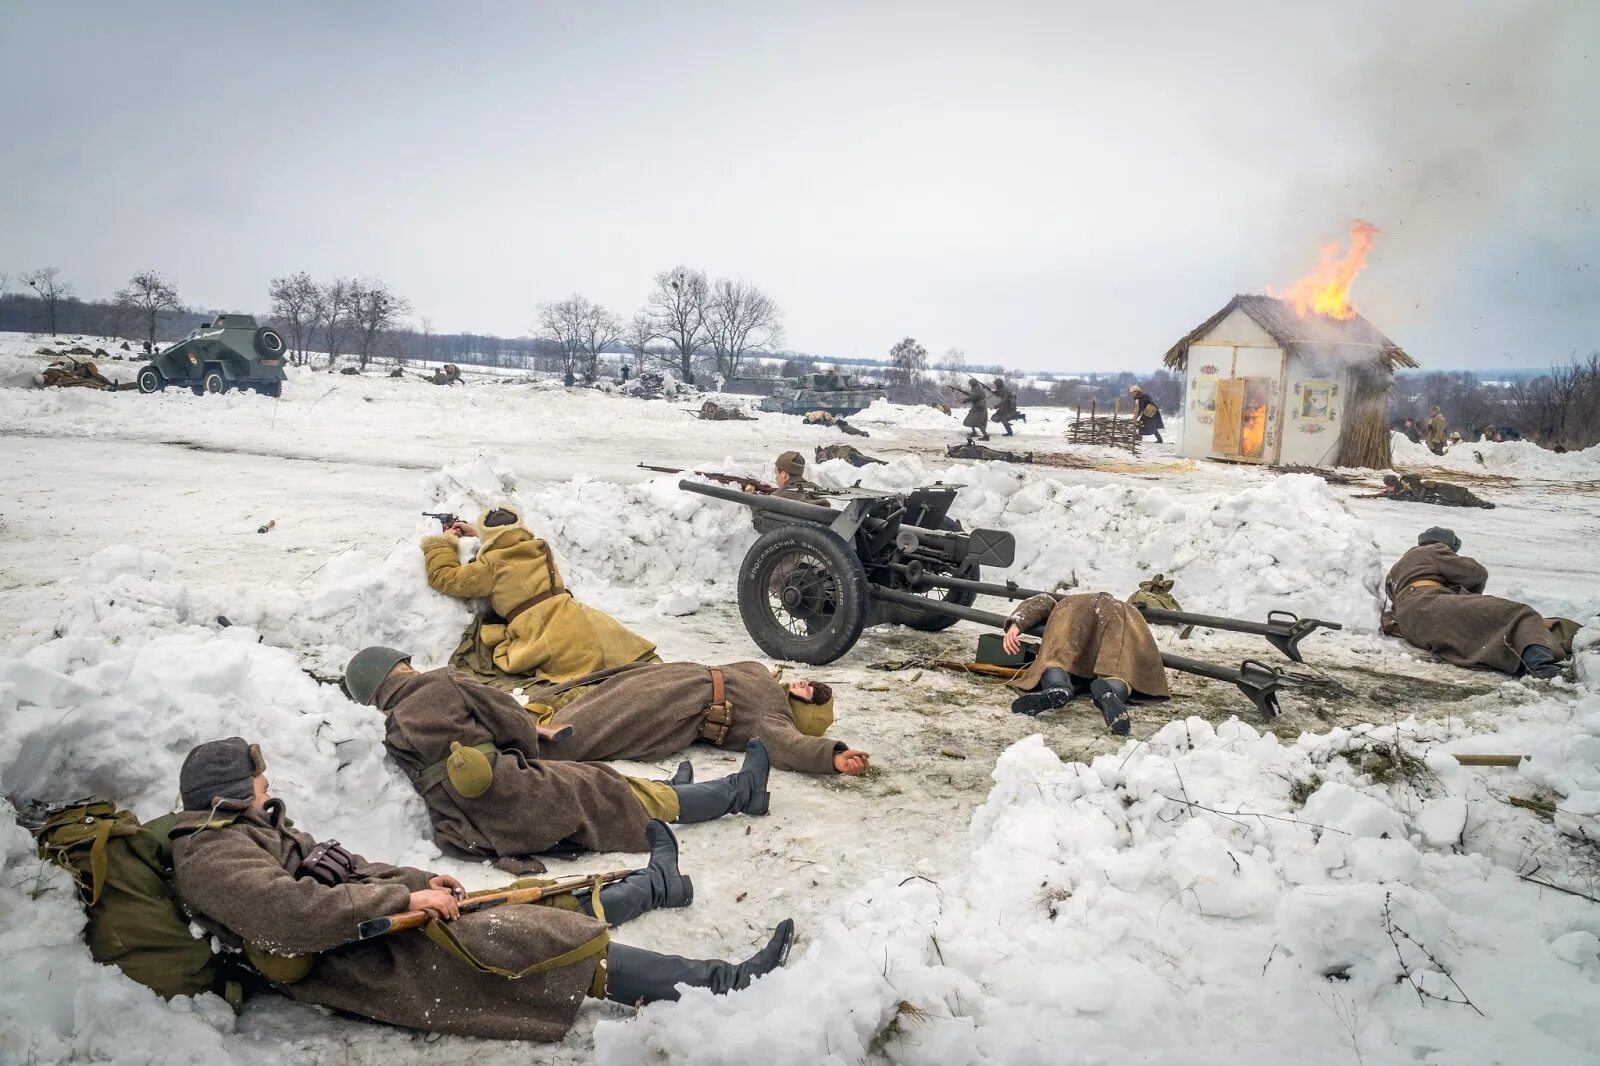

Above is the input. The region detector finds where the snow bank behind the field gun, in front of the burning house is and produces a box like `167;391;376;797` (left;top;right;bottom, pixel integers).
816;456;1382;631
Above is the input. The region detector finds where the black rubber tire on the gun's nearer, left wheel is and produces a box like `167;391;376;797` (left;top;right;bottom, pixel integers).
739;522;870;666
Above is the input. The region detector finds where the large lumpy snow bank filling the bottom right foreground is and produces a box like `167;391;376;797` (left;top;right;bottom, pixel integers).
595;719;1600;1066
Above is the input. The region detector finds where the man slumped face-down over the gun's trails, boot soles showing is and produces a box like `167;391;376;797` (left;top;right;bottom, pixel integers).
1002;592;1171;736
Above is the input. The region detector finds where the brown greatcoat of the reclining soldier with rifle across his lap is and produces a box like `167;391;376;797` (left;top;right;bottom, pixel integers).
173;800;605;1040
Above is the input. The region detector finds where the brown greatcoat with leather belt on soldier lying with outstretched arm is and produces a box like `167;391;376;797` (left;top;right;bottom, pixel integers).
530;663;846;773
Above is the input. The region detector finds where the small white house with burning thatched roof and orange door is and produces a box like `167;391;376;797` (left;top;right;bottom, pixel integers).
1165;296;1418;469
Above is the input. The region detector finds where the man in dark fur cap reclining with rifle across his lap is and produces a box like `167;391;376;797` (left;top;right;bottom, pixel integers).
171;736;794;1040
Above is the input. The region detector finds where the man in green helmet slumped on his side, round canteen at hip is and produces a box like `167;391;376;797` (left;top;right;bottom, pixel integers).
344;647;780;872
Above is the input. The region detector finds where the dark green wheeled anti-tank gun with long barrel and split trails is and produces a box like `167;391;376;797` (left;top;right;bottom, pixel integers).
678;480;1341;719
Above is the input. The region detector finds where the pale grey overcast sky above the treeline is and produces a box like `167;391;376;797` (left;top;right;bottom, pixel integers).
0;0;1600;371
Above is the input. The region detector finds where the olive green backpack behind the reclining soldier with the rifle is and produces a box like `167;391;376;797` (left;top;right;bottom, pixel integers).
34;800;220;999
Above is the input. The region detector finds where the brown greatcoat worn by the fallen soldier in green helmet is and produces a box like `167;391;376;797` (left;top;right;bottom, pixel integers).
376;667;650;869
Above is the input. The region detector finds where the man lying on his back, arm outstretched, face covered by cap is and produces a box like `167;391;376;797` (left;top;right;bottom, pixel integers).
528;663;870;776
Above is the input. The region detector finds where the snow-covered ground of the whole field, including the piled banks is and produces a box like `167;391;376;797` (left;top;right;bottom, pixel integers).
0;335;1600;1064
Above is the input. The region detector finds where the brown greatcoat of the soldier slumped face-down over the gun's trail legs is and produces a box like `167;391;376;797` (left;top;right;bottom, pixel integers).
1006;592;1171;699
